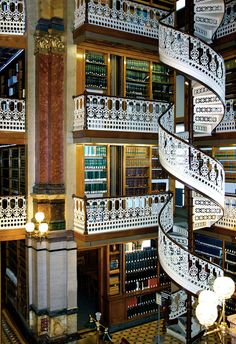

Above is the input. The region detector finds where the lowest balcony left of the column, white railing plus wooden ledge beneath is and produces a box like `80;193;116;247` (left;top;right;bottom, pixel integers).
0;196;26;241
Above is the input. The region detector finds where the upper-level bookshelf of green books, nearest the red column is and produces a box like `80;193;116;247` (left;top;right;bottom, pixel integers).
85;51;107;94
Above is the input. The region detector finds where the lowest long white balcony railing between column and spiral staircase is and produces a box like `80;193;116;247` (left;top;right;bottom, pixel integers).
74;193;169;234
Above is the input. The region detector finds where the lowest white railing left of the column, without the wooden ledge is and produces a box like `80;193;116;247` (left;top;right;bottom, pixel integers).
0;196;26;230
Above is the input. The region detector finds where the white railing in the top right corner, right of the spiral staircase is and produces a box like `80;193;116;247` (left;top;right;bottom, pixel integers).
216;0;236;38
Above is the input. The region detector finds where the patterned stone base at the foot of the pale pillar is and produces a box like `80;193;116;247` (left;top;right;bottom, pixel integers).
29;309;79;344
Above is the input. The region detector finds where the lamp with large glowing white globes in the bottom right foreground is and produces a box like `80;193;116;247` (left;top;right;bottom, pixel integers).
196;276;235;344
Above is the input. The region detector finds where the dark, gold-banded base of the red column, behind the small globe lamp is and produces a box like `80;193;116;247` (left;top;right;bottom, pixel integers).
32;194;65;230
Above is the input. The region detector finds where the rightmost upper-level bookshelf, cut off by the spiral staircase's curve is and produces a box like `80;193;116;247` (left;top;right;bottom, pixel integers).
152;62;173;102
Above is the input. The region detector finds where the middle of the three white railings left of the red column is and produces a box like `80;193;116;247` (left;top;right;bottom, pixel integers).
0;98;25;131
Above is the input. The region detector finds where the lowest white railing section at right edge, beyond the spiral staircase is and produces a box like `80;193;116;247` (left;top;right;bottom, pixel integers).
216;195;236;231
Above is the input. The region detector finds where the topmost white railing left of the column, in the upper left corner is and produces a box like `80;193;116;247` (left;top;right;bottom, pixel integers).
0;0;26;35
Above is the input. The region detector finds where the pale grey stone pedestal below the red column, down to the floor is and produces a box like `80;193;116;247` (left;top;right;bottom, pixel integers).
26;230;78;343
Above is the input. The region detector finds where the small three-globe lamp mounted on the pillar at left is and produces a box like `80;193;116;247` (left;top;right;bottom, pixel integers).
25;211;48;240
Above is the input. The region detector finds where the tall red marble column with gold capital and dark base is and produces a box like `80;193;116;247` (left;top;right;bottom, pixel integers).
32;29;65;230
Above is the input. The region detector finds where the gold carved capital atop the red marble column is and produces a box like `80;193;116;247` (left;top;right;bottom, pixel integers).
34;30;65;55
